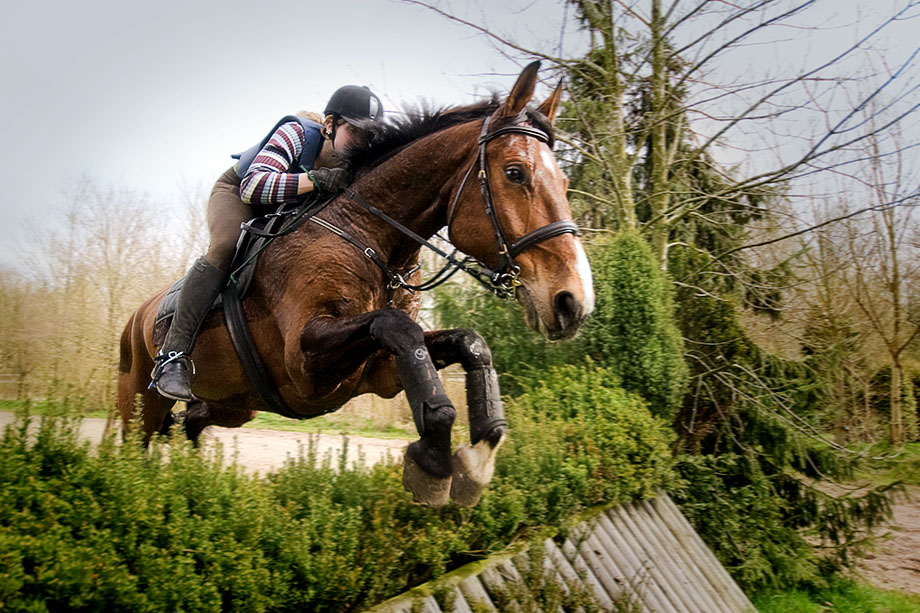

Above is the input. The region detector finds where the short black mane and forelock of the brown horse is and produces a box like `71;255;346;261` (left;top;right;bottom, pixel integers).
345;96;553;173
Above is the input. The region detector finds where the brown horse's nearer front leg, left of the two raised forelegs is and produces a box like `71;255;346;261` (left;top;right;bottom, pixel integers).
301;308;456;506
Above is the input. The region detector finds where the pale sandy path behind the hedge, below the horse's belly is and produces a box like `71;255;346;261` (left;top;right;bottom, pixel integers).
0;411;410;473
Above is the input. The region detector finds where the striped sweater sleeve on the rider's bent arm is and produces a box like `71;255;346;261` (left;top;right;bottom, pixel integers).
240;121;316;205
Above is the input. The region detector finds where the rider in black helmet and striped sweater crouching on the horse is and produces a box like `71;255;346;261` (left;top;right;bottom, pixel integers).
151;85;383;401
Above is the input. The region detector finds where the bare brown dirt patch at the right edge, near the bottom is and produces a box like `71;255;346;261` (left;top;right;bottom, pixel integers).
858;486;920;596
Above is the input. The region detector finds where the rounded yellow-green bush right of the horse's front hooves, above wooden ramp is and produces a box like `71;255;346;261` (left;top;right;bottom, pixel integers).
498;362;674;512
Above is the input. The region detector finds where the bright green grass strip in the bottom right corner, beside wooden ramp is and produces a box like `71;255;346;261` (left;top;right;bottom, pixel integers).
753;579;920;613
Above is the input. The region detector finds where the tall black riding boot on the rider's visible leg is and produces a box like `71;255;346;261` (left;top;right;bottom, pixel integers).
151;257;227;402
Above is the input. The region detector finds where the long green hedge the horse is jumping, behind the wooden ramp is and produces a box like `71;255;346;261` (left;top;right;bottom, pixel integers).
0;365;670;611
